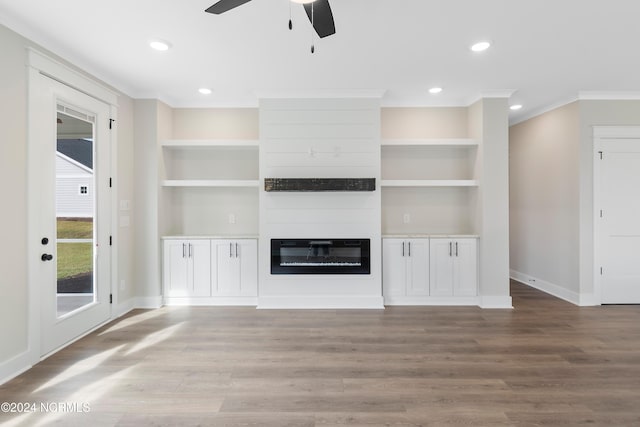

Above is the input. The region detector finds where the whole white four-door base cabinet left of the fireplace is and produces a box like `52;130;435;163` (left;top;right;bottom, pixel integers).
163;238;258;305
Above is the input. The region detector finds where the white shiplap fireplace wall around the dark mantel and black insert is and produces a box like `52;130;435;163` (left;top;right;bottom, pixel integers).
258;99;382;308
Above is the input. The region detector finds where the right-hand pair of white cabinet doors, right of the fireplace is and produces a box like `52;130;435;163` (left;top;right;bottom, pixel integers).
429;238;478;297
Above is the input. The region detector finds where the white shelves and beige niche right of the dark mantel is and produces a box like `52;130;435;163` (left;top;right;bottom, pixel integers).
380;138;480;235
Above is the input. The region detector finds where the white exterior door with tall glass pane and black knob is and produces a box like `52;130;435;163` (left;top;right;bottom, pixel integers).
28;70;112;355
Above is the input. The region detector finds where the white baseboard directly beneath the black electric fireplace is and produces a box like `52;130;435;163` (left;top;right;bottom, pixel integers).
258;295;384;310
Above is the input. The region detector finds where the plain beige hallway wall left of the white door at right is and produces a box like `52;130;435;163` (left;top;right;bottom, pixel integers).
509;102;580;301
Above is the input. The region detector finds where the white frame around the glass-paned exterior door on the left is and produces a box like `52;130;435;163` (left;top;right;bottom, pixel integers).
26;48;118;364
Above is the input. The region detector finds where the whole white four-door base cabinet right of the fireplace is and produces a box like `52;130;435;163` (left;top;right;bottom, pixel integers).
382;237;478;305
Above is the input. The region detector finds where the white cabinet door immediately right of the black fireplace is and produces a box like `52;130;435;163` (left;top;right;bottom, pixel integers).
382;239;407;296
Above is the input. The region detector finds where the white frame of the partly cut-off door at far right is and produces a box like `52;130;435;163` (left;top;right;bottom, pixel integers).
593;126;640;304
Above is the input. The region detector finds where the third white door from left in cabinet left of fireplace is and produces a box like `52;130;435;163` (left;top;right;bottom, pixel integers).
211;240;240;296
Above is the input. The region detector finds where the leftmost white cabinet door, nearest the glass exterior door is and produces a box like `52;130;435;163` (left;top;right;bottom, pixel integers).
163;240;190;297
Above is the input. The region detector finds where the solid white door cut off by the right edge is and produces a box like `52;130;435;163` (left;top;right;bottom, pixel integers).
595;132;640;304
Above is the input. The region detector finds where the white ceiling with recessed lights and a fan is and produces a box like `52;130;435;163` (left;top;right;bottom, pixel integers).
0;0;640;122
